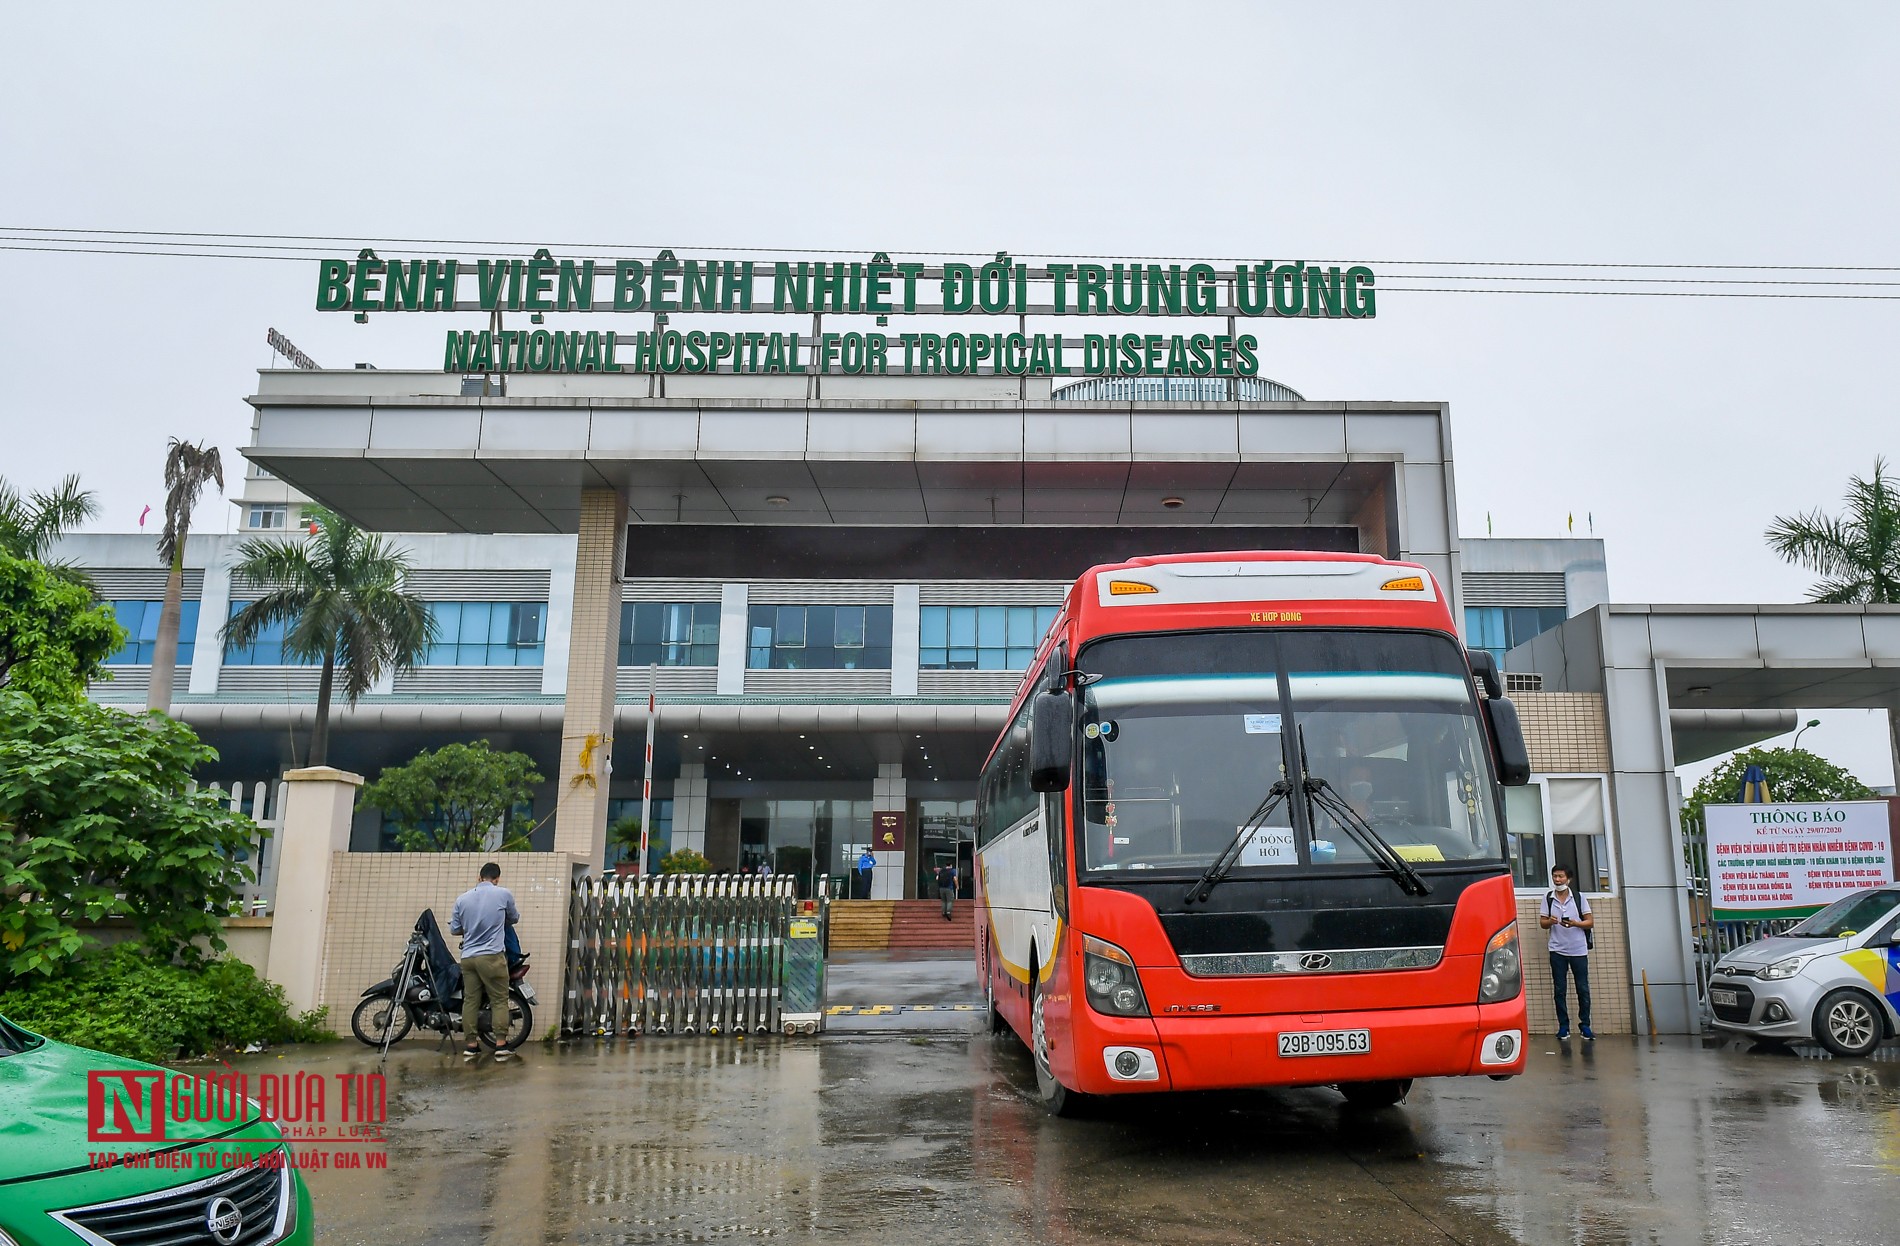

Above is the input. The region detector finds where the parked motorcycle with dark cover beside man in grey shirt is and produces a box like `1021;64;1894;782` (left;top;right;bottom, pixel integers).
350;908;538;1054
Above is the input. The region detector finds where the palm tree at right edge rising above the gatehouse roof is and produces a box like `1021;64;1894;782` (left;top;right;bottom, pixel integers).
1767;456;1900;775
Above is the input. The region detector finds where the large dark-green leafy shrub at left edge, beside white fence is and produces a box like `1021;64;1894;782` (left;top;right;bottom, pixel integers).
0;689;257;978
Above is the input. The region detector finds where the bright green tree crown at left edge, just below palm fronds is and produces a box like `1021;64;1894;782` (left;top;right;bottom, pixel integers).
0;551;125;701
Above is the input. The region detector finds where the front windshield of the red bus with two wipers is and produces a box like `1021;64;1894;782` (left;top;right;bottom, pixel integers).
1079;631;1503;878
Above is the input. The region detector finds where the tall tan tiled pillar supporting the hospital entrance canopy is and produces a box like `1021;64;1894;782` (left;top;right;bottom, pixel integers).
555;488;640;868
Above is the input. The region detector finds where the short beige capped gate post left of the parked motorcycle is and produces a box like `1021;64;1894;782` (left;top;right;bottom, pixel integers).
264;765;363;1012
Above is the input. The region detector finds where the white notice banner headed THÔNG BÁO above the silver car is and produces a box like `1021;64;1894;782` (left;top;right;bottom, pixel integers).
1702;800;1894;921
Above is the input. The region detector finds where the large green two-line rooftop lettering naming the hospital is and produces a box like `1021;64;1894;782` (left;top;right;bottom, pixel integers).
317;249;1378;376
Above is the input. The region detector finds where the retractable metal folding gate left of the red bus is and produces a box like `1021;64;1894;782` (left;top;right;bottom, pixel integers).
561;874;823;1037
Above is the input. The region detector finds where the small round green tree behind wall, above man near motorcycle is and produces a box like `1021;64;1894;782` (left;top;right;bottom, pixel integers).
361;741;542;853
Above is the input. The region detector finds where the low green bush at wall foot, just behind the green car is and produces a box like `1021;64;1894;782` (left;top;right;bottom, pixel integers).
0;944;336;1062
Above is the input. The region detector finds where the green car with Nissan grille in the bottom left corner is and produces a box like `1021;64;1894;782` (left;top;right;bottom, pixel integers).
0;1018;315;1246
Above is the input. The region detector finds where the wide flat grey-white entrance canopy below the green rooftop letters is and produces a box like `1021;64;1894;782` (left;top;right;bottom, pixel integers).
245;370;1450;541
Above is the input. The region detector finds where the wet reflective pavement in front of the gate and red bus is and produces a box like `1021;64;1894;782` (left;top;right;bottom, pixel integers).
243;1025;1900;1244
